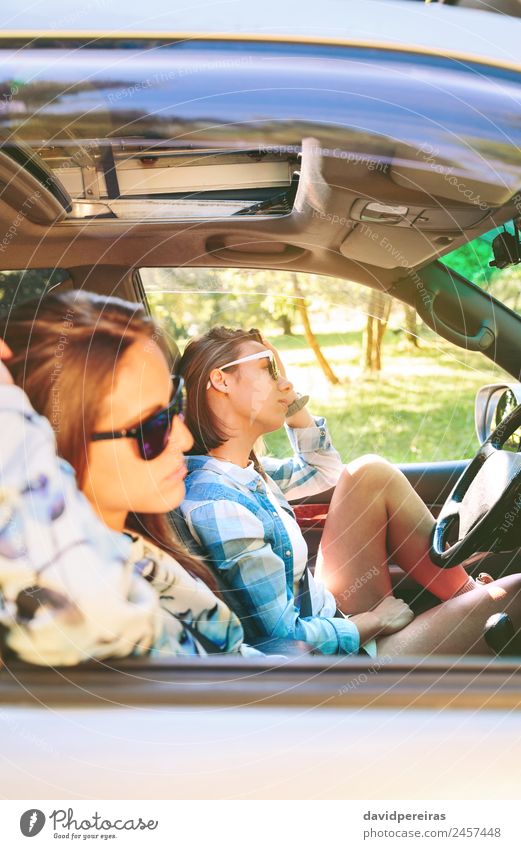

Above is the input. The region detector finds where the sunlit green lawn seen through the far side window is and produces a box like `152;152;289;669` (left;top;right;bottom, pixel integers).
265;329;511;462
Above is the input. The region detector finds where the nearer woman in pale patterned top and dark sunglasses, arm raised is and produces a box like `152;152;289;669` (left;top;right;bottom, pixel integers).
0;292;255;664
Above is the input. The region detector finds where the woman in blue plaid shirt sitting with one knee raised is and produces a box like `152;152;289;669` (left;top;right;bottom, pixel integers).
173;328;521;654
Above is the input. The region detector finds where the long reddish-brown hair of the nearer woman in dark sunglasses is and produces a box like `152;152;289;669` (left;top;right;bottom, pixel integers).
0;291;216;590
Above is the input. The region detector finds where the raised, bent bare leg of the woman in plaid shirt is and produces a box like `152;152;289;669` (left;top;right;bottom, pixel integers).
317;455;474;614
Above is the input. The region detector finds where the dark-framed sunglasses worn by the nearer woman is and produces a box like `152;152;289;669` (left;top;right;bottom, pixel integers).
91;375;185;460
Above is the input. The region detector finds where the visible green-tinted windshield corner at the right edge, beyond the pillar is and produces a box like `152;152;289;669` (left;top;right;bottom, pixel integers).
441;219;521;314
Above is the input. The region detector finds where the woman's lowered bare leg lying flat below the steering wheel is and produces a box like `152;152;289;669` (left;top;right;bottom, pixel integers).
377;575;521;656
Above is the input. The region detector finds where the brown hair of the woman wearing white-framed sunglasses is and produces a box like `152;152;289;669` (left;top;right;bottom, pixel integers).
177;327;264;476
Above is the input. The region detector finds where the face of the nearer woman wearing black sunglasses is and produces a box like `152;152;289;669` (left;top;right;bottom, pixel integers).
83;337;193;530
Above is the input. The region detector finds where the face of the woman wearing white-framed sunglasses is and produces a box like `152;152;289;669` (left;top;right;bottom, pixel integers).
210;341;293;435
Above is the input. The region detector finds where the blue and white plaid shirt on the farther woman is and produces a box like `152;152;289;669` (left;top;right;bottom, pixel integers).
174;418;360;654
